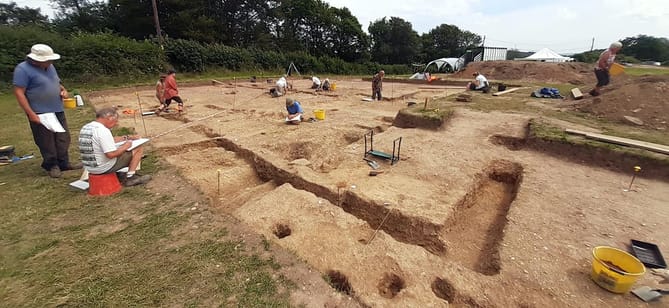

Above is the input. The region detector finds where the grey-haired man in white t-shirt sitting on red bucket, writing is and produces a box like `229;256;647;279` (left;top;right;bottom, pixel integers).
79;108;151;186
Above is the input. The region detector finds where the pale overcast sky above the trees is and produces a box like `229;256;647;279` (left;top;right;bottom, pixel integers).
9;0;669;53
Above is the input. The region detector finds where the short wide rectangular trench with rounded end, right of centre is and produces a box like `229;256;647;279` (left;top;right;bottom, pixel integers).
442;160;523;276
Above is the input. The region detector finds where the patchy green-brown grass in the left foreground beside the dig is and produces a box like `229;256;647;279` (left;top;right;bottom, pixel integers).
0;94;293;307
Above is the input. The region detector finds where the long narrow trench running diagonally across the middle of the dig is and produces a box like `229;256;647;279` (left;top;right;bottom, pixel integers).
177;128;446;255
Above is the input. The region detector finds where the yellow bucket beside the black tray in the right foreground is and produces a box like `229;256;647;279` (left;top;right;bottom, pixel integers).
590;246;646;293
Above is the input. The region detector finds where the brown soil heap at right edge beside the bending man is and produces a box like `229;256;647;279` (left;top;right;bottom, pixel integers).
578;76;669;130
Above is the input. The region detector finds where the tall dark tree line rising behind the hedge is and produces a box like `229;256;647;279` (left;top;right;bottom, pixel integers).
0;0;481;64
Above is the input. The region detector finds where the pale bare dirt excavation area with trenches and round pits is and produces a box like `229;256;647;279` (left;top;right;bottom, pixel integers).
88;69;669;307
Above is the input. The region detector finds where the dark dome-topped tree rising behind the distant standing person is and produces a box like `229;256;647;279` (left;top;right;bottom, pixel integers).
368;17;420;64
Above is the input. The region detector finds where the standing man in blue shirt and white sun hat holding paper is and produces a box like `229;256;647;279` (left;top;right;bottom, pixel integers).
14;44;82;178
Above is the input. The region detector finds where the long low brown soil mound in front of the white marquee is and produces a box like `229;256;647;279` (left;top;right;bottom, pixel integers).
453;61;595;85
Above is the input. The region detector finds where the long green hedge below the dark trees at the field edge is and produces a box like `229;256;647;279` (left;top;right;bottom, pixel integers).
0;26;411;84
